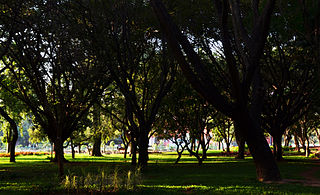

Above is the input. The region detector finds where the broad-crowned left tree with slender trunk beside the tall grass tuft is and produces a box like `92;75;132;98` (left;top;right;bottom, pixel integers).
0;0;110;175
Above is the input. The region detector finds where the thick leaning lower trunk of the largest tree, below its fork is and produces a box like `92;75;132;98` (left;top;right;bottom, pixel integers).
237;113;281;181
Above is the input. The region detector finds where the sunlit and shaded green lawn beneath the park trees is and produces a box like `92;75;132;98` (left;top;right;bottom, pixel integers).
0;151;320;194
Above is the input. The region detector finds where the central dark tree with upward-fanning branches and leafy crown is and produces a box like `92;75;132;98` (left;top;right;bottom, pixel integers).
84;1;175;166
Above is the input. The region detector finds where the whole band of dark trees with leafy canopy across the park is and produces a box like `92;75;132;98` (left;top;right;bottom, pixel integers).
0;0;320;180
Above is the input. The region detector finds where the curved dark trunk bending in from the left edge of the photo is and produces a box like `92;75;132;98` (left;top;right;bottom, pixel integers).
0;107;18;162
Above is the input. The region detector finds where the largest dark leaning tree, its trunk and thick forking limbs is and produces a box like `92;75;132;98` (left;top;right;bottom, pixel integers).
151;0;280;181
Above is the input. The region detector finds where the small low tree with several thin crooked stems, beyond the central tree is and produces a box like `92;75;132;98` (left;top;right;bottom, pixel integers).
156;71;214;164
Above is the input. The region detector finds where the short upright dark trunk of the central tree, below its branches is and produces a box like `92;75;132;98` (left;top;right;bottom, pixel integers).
138;130;149;167
